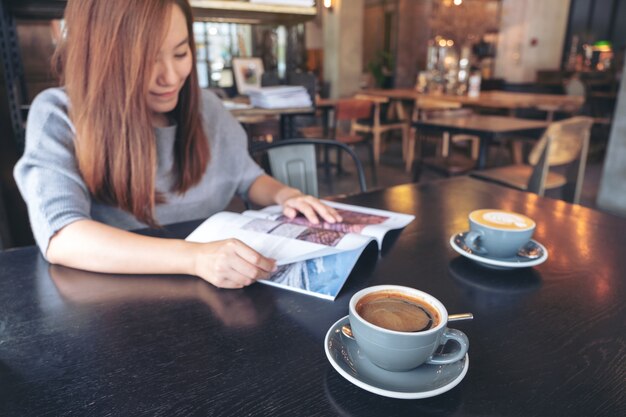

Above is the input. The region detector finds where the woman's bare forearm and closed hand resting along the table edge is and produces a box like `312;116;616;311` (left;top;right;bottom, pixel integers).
46;220;275;288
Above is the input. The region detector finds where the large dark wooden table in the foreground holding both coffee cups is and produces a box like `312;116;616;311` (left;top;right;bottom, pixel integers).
0;178;626;417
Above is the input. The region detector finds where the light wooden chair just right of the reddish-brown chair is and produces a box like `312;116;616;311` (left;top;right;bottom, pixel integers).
352;94;410;165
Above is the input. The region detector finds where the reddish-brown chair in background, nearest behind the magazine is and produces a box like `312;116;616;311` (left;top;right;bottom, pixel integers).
331;98;377;184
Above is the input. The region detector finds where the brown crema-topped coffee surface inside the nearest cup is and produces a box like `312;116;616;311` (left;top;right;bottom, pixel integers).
356;291;441;332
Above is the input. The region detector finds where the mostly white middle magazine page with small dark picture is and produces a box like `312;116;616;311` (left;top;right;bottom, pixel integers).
186;212;371;265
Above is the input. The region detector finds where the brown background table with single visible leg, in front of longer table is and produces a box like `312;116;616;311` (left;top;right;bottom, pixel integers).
413;114;549;169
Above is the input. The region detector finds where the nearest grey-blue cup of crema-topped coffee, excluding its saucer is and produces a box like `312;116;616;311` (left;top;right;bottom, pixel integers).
349;285;469;371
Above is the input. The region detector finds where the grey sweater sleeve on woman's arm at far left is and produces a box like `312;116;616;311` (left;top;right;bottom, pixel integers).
13;88;91;256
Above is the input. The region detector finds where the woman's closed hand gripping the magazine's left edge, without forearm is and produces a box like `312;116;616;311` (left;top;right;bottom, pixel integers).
193;239;276;288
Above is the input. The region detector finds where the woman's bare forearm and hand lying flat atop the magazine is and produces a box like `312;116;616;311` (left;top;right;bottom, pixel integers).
248;175;341;224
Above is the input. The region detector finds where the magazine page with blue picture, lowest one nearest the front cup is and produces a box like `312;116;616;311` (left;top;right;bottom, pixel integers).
258;248;364;300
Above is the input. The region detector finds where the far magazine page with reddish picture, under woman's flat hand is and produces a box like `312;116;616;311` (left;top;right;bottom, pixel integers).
243;200;415;249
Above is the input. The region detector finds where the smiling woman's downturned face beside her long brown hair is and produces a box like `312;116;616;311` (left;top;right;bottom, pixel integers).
147;6;193;127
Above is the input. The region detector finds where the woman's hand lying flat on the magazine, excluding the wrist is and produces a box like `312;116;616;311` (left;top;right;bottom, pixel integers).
276;187;342;224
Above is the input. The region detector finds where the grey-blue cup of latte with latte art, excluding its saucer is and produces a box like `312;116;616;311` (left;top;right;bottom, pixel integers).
465;209;536;258
